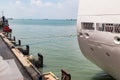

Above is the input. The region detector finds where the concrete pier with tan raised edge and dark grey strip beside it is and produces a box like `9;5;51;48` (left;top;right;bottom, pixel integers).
0;32;58;80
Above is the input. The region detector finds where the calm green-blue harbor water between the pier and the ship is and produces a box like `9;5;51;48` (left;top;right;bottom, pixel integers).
9;19;112;80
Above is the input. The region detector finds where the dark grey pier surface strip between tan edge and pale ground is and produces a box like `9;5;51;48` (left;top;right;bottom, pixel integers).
0;36;32;80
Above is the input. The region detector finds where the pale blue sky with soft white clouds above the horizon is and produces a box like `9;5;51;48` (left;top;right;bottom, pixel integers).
0;0;79;19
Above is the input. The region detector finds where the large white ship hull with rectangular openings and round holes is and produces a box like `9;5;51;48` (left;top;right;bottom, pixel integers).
77;0;120;80
